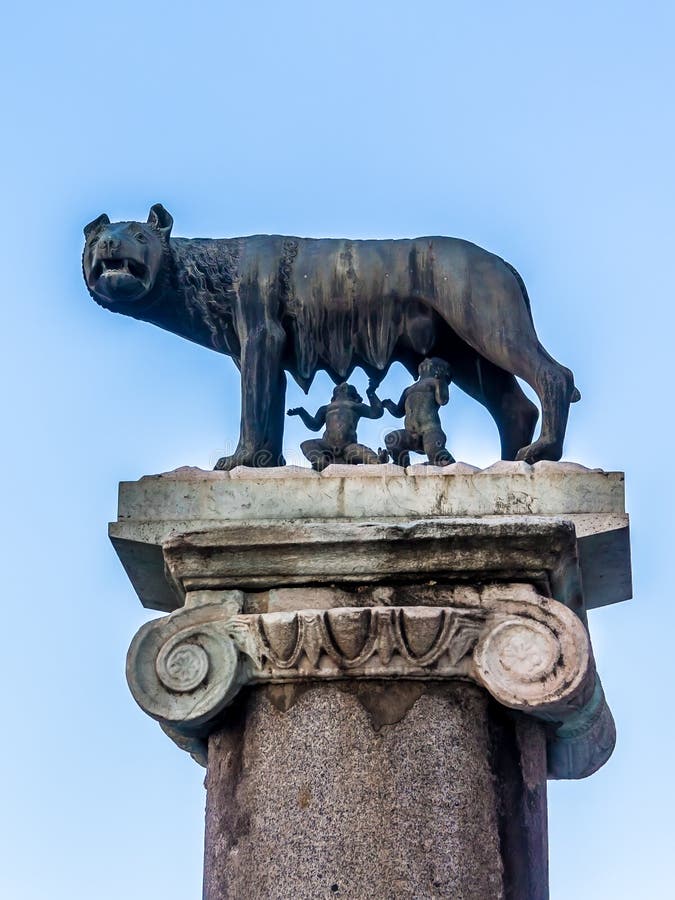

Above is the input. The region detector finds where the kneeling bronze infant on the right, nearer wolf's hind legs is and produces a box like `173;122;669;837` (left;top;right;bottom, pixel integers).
382;357;455;466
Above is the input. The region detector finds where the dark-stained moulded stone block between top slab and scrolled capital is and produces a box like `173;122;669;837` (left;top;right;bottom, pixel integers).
158;516;582;613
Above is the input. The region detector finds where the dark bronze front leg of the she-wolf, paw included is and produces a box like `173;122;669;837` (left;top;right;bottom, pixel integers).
215;322;286;470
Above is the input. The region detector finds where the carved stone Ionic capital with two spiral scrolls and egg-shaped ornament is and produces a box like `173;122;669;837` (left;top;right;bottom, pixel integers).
127;587;613;778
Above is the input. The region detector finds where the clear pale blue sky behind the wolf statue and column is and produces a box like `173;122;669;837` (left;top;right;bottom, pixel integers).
0;0;675;900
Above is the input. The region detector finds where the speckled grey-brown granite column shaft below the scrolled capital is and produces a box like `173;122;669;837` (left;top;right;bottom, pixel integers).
204;682;546;900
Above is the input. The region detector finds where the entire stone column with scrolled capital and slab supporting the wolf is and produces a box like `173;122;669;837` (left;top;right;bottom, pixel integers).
111;463;630;900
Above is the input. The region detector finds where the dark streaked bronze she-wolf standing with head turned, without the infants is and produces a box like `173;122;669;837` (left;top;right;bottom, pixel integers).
83;204;579;469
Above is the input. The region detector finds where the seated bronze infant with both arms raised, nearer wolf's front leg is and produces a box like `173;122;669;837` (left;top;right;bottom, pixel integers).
288;383;388;472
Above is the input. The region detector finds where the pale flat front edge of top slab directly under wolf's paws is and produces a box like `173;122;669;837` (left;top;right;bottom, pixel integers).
119;461;624;523
